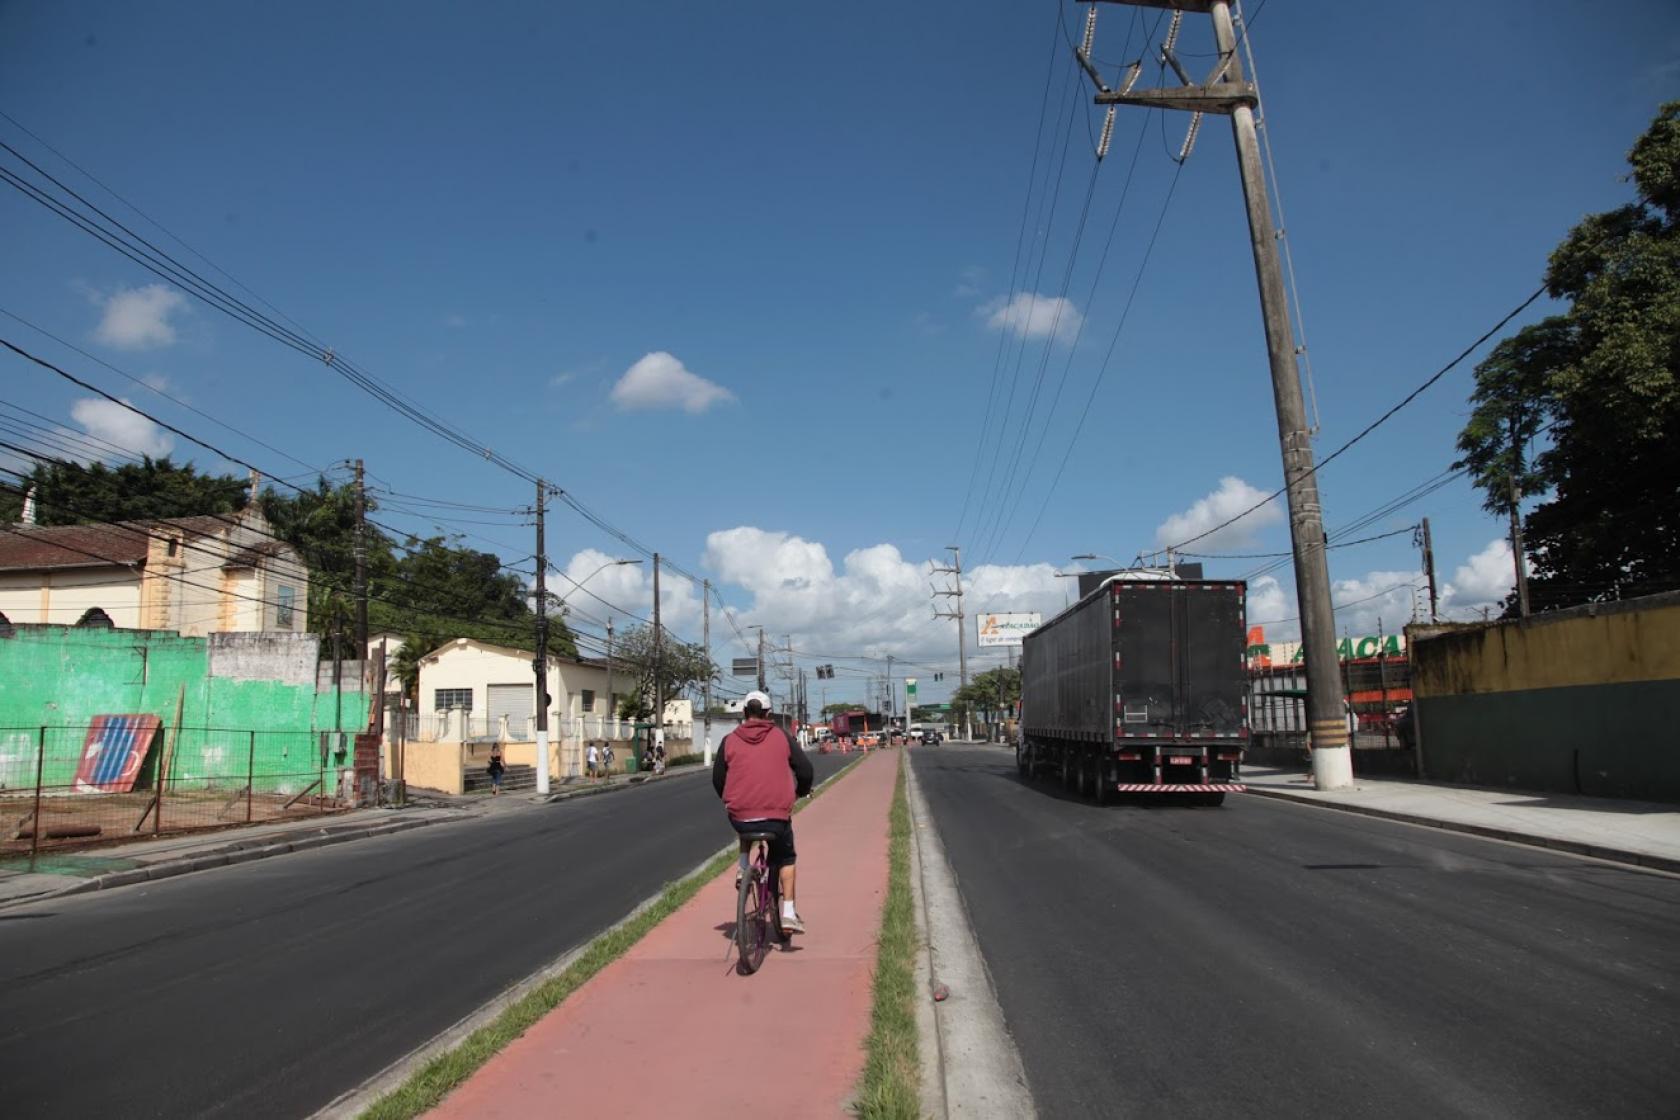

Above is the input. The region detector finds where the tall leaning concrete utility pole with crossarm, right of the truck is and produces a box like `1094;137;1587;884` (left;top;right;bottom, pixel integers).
1079;0;1352;789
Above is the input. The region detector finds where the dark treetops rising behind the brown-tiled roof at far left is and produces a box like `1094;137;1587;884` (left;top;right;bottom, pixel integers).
0;457;250;526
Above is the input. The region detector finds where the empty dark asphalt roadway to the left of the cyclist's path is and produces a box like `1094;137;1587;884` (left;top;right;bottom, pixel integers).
0;754;852;1118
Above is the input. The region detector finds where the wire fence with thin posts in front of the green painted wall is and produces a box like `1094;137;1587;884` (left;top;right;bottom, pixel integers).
0;727;353;858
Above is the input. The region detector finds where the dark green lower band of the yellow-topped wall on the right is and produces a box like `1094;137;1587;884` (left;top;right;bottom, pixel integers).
1416;680;1680;801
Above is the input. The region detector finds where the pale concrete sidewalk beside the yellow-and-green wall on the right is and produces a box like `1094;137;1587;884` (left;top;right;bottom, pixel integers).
1243;766;1680;871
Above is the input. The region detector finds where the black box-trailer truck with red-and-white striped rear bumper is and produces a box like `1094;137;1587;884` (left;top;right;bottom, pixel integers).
1015;573;1248;804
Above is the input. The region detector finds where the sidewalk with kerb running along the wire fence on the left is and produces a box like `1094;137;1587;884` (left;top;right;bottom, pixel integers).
0;808;470;908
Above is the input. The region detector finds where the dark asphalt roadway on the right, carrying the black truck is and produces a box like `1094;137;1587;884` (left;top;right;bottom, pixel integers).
911;747;1680;1120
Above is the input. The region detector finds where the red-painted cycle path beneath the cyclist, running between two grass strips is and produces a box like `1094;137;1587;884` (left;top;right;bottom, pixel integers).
430;751;902;1120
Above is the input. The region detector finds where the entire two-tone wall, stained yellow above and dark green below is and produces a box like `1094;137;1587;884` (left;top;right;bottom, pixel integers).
1411;594;1680;801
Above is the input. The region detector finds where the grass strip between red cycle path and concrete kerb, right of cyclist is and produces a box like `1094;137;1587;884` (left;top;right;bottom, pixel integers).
857;756;921;1120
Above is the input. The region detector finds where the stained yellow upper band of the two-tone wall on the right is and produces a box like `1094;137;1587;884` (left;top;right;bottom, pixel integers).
1411;596;1680;700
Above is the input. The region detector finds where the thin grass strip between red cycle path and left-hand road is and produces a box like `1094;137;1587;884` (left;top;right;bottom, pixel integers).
358;757;873;1120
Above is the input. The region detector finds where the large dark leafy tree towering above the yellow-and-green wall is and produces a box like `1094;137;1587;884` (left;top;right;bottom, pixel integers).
1458;101;1680;610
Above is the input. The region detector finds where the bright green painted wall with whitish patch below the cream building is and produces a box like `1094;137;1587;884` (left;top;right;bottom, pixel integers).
0;626;371;793
